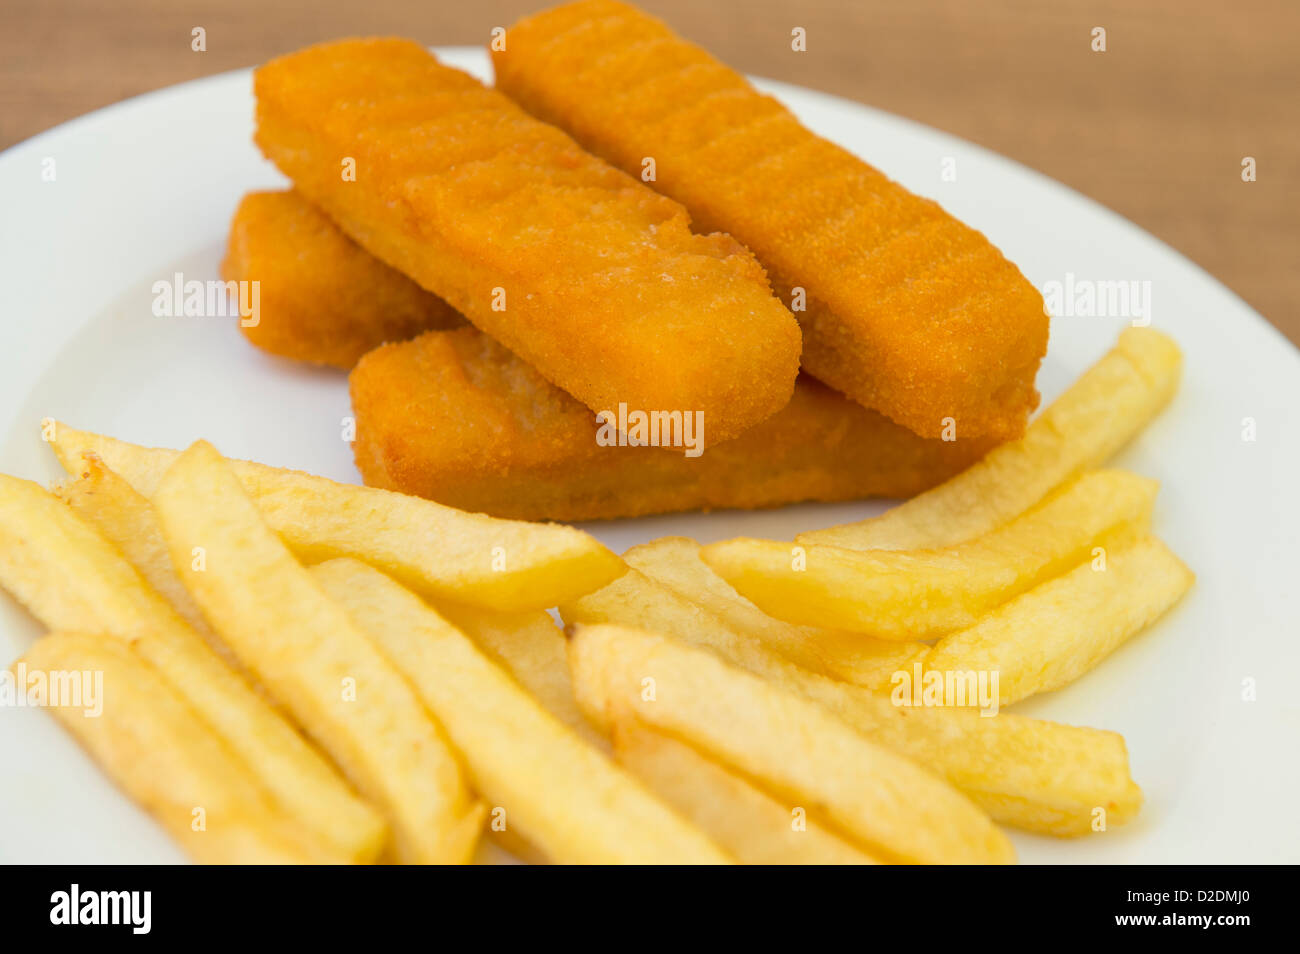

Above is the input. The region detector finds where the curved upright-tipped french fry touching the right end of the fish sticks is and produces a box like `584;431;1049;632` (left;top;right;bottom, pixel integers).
794;328;1183;550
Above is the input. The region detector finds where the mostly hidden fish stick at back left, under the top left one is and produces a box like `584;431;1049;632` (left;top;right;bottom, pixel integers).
221;191;465;370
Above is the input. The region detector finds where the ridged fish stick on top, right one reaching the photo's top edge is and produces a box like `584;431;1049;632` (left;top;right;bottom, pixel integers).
493;0;1048;439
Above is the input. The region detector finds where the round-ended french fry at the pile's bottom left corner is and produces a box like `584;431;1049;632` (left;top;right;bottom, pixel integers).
14;633;327;864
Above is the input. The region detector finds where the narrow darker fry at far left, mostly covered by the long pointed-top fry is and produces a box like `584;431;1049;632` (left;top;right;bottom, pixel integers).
53;454;220;651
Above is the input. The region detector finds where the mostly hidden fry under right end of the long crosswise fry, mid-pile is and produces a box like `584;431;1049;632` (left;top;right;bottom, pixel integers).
434;603;610;751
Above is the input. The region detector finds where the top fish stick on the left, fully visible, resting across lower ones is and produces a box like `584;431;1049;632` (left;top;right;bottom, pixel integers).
254;39;800;442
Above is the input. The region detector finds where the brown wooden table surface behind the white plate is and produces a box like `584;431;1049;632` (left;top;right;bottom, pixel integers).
0;0;1300;343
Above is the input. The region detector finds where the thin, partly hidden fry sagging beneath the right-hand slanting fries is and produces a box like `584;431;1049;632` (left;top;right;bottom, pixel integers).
623;537;930;689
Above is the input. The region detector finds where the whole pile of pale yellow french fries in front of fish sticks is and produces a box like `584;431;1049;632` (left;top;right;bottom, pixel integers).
0;329;1192;864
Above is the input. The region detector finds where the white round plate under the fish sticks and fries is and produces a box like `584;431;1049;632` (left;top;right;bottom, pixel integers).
0;48;1300;862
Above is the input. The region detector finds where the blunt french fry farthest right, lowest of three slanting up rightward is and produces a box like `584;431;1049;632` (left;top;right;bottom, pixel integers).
923;537;1195;706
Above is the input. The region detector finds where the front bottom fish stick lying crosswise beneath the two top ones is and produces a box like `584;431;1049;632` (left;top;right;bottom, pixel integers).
351;328;991;521
